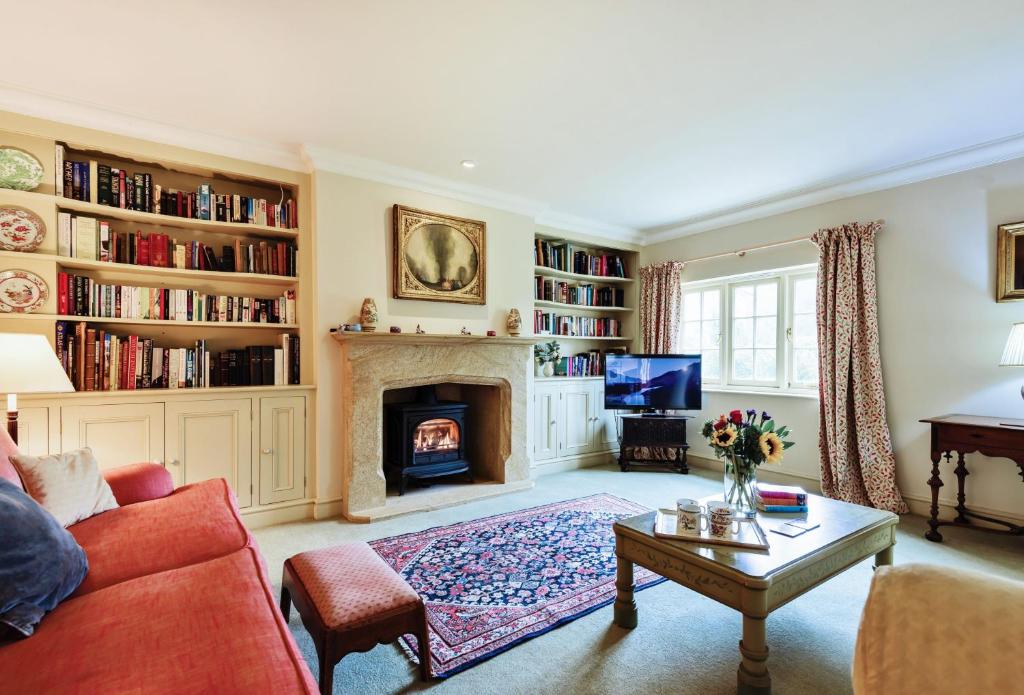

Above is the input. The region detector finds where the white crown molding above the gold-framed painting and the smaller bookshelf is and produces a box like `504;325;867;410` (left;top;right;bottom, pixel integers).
303;144;640;244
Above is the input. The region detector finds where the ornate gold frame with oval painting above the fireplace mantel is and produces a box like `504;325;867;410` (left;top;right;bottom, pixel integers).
392;205;487;304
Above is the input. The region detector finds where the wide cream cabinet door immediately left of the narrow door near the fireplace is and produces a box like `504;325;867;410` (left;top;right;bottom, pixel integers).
167;398;253;508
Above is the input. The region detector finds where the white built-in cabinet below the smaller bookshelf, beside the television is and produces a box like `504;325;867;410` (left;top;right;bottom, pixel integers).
534;379;618;466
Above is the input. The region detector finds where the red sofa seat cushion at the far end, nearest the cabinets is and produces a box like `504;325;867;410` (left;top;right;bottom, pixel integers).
68;478;251;596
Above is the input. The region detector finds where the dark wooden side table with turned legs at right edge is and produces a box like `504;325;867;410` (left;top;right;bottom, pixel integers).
921;415;1024;542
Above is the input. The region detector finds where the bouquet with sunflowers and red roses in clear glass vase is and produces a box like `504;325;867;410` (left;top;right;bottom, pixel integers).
700;408;794;516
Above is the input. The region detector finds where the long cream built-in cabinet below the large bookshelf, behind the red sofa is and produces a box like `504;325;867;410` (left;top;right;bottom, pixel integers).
34;393;309;509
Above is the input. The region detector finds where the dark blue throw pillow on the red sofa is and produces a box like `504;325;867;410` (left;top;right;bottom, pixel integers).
0;478;89;637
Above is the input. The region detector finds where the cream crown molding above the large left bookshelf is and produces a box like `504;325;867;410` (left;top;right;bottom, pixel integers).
0;82;308;172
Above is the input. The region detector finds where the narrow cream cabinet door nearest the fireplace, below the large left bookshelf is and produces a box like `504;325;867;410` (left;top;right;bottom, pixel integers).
259;396;306;505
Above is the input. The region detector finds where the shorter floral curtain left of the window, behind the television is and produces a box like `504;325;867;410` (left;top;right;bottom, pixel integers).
640;261;683;354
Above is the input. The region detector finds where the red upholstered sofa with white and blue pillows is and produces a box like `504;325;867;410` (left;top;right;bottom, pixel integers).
0;429;317;695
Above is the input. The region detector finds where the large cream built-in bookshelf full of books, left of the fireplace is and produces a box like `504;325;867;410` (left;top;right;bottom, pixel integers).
0;119;313;397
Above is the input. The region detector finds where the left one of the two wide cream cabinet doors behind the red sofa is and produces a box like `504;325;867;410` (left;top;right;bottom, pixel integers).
60;403;164;470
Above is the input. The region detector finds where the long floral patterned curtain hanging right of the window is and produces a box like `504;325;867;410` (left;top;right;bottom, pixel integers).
811;222;908;514
